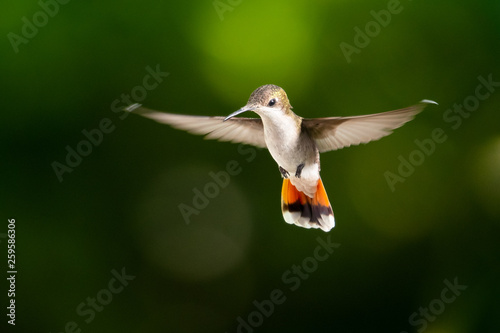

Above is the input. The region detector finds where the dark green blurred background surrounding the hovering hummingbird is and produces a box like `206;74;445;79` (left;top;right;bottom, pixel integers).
0;0;500;333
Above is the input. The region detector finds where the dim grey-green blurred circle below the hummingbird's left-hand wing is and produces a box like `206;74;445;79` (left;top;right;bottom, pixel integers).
137;166;251;280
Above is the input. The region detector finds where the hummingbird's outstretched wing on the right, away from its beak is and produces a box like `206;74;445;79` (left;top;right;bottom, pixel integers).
302;100;437;152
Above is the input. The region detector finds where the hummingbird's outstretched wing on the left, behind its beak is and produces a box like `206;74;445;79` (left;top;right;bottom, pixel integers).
125;104;267;148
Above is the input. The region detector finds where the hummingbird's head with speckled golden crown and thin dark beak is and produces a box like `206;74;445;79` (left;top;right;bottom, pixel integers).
224;84;292;121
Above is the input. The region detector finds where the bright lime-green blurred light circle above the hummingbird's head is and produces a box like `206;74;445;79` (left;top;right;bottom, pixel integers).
191;1;317;104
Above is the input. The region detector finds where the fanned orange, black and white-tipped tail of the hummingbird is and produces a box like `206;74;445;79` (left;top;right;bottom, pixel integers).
281;178;335;231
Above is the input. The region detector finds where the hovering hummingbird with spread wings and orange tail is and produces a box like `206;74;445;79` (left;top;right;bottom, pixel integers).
125;84;437;232
